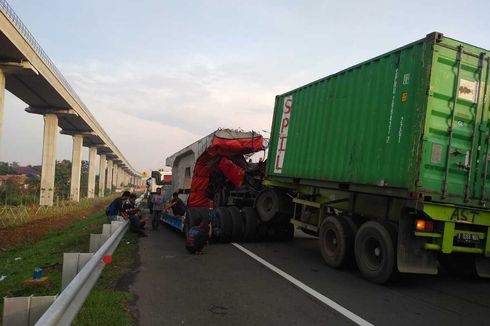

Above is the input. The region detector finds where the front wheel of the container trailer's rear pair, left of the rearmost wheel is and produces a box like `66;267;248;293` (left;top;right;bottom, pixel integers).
319;215;354;268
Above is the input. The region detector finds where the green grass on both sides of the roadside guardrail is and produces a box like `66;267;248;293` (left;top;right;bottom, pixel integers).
0;210;137;325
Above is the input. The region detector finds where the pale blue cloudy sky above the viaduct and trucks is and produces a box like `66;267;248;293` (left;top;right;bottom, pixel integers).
0;0;490;172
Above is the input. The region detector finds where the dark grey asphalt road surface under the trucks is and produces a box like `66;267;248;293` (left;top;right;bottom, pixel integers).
130;226;490;326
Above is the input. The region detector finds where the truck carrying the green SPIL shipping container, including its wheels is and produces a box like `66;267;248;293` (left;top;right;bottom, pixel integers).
168;32;490;283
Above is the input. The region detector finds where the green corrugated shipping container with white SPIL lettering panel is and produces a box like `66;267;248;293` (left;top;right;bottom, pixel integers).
267;33;490;208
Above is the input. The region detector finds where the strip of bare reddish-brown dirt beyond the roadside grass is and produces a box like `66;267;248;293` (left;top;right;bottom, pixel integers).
0;203;106;251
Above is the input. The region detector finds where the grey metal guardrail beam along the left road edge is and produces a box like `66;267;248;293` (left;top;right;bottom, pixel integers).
35;221;129;326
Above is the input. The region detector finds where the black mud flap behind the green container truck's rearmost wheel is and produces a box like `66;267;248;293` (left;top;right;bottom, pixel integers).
397;214;437;274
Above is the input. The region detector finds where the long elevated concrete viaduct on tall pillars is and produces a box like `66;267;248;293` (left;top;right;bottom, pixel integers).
0;0;143;206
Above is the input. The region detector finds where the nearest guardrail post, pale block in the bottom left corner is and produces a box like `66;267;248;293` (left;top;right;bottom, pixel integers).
3;295;56;326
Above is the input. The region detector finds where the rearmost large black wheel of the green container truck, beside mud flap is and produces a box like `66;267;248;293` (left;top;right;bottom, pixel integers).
354;221;396;284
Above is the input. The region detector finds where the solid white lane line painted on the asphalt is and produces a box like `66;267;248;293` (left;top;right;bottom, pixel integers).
232;242;374;326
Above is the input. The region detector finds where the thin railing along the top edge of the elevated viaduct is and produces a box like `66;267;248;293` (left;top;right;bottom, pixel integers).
0;0;136;171
